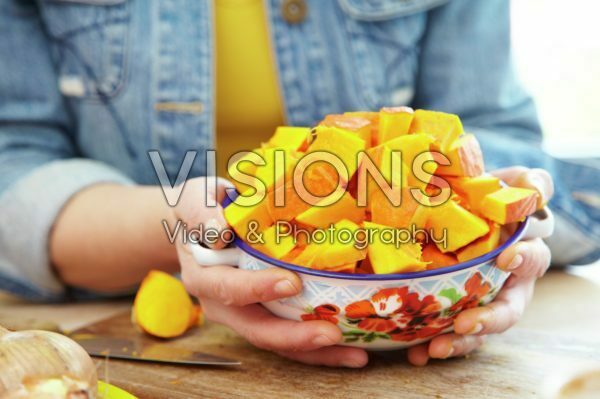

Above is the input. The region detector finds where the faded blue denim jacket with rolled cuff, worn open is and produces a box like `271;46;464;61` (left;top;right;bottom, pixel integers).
0;0;600;300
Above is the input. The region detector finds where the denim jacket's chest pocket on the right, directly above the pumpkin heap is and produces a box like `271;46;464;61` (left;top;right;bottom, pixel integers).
338;0;449;109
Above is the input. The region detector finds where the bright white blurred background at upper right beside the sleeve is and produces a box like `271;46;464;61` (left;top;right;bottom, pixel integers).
512;0;600;158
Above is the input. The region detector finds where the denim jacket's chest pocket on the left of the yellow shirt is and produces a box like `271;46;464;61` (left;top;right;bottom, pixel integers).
40;0;130;100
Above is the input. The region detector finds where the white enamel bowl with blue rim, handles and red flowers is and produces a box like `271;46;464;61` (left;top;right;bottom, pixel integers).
191;206;553;350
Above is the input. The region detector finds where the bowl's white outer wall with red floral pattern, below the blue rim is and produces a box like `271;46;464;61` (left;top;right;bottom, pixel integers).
239;251;510;350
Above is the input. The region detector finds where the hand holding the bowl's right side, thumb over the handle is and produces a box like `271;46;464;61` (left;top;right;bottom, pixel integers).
408;167;554;366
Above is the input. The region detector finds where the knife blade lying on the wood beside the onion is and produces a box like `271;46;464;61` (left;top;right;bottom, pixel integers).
71;334;242;366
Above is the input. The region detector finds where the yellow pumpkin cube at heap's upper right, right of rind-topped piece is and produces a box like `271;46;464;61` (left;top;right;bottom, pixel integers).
409;109;463;153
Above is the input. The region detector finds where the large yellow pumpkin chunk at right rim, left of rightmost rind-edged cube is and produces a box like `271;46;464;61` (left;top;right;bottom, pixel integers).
427;200;490;253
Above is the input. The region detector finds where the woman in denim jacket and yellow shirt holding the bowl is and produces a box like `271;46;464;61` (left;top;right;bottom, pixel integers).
0;0;592;367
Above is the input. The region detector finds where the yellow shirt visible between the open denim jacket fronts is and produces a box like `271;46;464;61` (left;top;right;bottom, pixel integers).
214;0;283;176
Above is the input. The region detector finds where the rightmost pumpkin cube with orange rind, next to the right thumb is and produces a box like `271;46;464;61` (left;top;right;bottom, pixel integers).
480;187;538;224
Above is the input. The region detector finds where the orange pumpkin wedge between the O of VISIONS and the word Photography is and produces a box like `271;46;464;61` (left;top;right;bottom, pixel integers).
296;192;365;228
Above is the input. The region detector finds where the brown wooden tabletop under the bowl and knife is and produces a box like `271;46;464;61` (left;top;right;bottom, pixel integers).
81;315;600;399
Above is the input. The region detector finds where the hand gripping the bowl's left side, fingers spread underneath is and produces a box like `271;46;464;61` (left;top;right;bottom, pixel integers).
171;178;368;367
